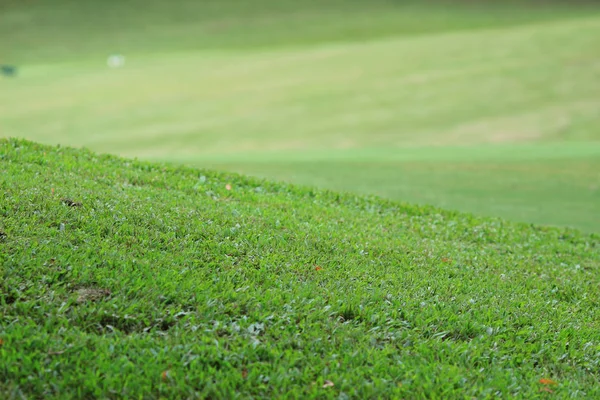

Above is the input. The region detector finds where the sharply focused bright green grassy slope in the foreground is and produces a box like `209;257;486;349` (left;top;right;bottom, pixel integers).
0;140;600;399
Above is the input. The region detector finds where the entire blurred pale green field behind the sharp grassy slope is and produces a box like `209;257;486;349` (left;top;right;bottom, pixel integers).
0;0;600;232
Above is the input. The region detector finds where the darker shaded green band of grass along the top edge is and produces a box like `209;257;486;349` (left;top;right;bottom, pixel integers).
0;0;597;63
